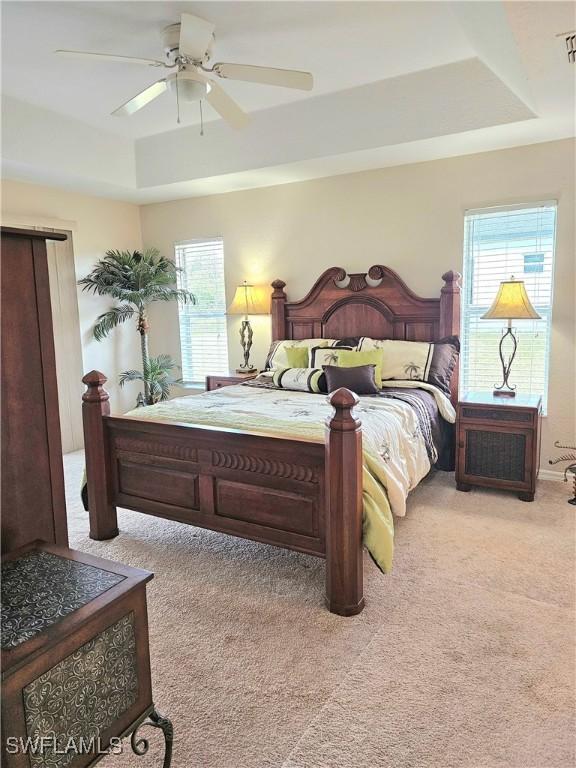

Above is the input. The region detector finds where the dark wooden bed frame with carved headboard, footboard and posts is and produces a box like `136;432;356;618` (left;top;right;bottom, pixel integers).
82;265;460;616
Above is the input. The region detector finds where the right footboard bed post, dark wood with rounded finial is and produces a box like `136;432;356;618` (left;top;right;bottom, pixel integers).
325;388;364;616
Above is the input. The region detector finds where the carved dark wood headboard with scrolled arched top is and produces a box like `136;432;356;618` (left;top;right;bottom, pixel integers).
272;264;460;402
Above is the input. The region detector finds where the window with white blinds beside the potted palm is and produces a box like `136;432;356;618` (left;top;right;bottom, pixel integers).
174;237;228;384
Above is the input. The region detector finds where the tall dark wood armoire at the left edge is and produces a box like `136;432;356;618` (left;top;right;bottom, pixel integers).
0;227;68;552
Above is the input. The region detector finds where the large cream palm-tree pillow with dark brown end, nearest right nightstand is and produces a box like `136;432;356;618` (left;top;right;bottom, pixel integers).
358;336;460;395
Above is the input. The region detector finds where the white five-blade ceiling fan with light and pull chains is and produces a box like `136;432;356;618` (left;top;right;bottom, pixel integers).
55;13;313;128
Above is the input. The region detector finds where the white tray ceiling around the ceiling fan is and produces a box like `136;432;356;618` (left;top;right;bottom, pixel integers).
2;0;576;200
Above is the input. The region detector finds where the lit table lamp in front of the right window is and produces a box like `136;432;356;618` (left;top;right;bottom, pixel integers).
481;275;540;397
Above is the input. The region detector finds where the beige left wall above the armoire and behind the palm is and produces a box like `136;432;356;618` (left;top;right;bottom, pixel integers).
2;181;142;412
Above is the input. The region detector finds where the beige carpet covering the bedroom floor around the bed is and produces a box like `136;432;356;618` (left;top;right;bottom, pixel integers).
65;453;576;768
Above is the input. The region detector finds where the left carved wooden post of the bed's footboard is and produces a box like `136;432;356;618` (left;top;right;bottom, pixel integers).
82;371;118;540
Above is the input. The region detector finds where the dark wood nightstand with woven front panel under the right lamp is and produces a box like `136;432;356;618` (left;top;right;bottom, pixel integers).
456;392;542;501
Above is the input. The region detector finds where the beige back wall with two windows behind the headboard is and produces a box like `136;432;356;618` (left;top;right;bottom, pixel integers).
141;140;576;468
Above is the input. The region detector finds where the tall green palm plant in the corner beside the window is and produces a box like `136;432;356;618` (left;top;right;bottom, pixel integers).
78;248;196;405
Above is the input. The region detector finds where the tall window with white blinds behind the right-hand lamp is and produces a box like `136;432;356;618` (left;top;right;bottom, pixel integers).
461;202;556;411
